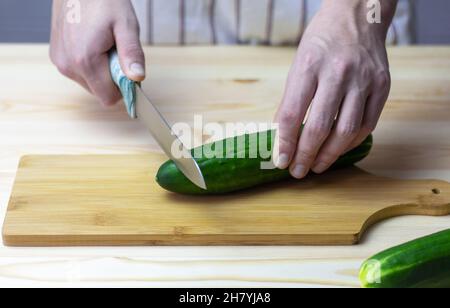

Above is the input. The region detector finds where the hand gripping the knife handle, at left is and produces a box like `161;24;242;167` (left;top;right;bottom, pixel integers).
50;0;145;106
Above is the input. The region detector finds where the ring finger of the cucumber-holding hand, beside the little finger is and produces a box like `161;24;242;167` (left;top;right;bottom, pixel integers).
312;91;367;173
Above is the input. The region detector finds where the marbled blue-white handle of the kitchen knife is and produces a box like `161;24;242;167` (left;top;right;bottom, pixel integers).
109;49;136;119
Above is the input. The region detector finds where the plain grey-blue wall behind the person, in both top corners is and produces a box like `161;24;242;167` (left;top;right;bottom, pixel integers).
0;0;450;44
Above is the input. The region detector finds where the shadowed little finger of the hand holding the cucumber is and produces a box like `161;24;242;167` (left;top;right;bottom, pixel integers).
346;74;391;152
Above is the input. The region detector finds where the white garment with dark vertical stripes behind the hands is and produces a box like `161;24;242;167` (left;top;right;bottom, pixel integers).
132;0;412;45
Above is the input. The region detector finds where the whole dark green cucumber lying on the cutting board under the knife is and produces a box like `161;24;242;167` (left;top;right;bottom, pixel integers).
156;131;372;195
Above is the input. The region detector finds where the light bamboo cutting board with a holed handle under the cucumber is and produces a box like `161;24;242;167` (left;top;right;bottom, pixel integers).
3;154;450;246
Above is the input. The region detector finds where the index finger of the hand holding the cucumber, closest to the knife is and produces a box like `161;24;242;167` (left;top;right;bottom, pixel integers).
274;72;317;169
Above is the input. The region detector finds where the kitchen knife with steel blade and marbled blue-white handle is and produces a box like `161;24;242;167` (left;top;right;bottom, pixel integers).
109;50;207;190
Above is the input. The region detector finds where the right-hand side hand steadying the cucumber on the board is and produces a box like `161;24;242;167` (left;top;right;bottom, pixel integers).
276;0;395;179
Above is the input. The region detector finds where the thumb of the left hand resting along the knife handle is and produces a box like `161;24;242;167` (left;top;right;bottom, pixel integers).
114;21;145;82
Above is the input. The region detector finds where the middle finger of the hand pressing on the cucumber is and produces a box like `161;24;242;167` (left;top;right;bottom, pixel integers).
290;81;343;179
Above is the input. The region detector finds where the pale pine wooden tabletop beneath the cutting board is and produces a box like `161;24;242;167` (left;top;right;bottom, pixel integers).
0;45;450;287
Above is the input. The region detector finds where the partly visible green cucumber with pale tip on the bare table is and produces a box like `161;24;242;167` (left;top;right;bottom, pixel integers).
359;230;450;288
